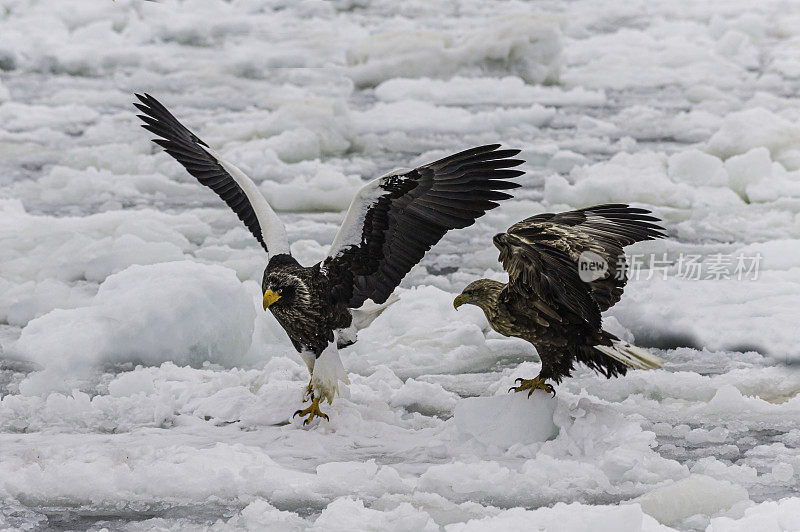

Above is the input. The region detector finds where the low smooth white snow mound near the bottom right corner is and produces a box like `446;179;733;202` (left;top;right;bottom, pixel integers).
630;475;750;525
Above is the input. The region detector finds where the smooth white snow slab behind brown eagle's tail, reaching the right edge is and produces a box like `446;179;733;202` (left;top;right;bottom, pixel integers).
612;270;800;360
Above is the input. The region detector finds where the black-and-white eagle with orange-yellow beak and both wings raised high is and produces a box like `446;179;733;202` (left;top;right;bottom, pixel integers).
134;94;524;424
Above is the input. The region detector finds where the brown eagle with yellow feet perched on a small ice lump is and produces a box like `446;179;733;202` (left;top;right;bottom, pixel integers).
453;204;665;397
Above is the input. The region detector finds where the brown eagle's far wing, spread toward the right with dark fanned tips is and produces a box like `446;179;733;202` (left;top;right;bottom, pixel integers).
501;203;665;312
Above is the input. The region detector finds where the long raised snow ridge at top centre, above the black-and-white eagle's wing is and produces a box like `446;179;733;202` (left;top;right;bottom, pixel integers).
346;14;561;87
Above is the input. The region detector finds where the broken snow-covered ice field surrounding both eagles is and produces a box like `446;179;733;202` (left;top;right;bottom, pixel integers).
0;0;800;532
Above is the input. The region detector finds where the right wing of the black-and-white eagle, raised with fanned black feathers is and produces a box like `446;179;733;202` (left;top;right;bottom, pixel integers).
324;144;524;308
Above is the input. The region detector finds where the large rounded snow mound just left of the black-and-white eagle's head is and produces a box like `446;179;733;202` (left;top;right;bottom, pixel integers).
14;261;255;390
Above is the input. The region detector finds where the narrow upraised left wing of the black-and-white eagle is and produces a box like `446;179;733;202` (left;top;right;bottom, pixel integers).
133;94;289;254
